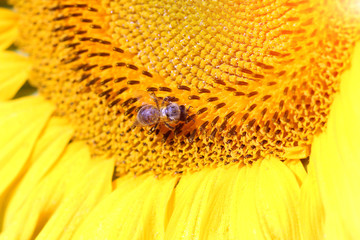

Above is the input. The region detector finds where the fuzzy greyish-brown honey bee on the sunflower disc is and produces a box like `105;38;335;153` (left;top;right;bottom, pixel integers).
133;94;190;130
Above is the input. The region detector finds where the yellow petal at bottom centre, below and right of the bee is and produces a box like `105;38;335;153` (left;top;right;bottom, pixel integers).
165;167;243;239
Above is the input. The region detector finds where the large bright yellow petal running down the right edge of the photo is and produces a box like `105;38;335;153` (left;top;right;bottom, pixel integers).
310;44;360;239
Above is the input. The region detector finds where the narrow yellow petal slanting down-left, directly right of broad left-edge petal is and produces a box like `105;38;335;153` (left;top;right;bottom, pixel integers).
6;118;73;220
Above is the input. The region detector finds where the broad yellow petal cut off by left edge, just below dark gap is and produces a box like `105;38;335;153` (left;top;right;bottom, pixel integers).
0;97;53;199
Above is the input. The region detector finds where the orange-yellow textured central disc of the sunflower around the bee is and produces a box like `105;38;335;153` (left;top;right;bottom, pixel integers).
14;0;360;176
